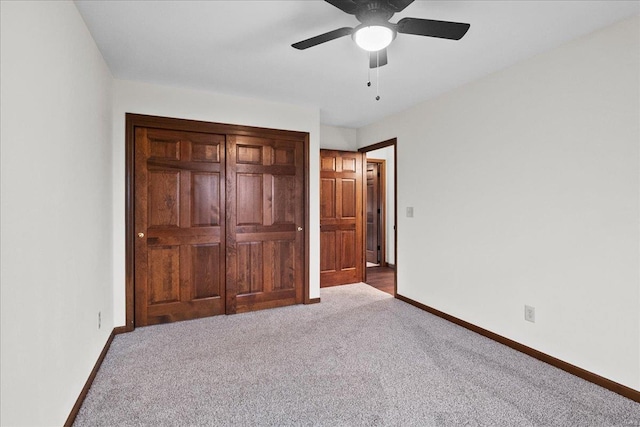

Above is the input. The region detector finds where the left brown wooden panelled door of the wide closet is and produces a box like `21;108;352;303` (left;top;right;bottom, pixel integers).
134;127;225;326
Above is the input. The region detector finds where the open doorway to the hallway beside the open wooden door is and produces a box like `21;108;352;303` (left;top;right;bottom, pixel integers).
358;138;398;296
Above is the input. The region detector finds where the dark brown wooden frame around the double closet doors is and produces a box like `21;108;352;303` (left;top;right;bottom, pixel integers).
124;113;310;332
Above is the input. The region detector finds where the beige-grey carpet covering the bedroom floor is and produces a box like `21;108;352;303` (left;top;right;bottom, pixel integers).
75;284;640;427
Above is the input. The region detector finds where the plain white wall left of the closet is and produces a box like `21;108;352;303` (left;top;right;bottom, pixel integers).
0;1;113;426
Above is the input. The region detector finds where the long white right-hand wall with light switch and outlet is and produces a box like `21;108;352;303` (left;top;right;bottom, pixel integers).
358;17;640;390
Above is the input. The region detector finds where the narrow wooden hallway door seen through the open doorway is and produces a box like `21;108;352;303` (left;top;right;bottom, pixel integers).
366;160;382;264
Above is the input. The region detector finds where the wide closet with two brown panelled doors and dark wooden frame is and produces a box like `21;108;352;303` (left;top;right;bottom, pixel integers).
126;113;312;330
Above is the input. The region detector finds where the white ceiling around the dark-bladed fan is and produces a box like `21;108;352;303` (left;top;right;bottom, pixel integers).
76;0;640;128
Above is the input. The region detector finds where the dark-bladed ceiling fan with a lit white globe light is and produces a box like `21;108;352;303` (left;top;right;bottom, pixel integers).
291;0;470;68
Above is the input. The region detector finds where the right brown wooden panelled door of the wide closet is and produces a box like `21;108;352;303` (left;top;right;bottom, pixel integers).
227;135;305;313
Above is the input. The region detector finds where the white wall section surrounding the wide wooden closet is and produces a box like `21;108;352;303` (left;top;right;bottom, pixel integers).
113;80;320;325
